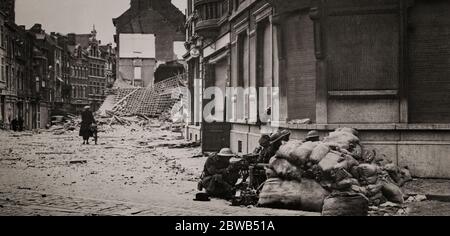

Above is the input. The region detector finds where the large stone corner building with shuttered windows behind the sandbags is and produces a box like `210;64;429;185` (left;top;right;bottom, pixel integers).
185;0;450;178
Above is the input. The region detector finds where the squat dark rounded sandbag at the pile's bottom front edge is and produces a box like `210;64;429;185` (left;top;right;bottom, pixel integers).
322;192;369;216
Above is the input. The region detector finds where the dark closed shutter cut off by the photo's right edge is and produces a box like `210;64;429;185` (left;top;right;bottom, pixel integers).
408;0;450;123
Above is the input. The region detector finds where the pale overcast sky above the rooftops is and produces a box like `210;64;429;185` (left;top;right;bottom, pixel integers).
16;0;187;44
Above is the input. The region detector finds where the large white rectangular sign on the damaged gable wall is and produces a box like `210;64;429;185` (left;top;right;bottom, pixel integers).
119;34;156;58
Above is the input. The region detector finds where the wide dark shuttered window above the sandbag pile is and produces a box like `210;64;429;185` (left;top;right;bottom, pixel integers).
326;13;399;91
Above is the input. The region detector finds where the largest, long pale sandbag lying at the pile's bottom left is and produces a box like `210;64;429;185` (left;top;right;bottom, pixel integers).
258;178;329;212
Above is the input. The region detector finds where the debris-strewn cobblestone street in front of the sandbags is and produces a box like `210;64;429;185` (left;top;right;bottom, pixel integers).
0;127;319;216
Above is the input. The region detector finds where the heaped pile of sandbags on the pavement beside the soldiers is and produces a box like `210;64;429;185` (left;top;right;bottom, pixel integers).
258;128;412;215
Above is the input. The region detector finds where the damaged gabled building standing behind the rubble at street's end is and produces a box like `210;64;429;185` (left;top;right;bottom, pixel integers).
113;0;186;87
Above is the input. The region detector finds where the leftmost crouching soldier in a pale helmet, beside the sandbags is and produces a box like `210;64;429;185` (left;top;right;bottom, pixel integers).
198;148;240;199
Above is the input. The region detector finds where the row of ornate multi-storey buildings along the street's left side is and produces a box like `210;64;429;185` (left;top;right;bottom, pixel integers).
0;0;115;130
